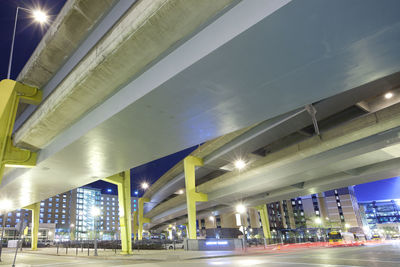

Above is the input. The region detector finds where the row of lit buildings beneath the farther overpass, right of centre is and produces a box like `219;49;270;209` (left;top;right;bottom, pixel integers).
169;187;363;240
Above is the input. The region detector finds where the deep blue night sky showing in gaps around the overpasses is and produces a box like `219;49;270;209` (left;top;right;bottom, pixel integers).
0;0;400;201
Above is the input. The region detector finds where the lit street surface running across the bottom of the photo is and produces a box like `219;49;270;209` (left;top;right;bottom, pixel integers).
0;242;400;267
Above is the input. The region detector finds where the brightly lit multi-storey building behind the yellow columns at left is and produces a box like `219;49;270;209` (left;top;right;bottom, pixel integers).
0;187;138;241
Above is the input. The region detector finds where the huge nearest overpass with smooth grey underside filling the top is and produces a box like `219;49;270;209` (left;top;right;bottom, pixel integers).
0;0;400;251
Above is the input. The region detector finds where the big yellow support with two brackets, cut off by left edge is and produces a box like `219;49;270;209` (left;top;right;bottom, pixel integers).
0;80;42;184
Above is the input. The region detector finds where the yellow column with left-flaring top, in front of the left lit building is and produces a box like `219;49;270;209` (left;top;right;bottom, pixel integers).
103;170;132;254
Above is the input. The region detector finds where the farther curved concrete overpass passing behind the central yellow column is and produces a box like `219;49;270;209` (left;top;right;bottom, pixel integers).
144;80;400;228
